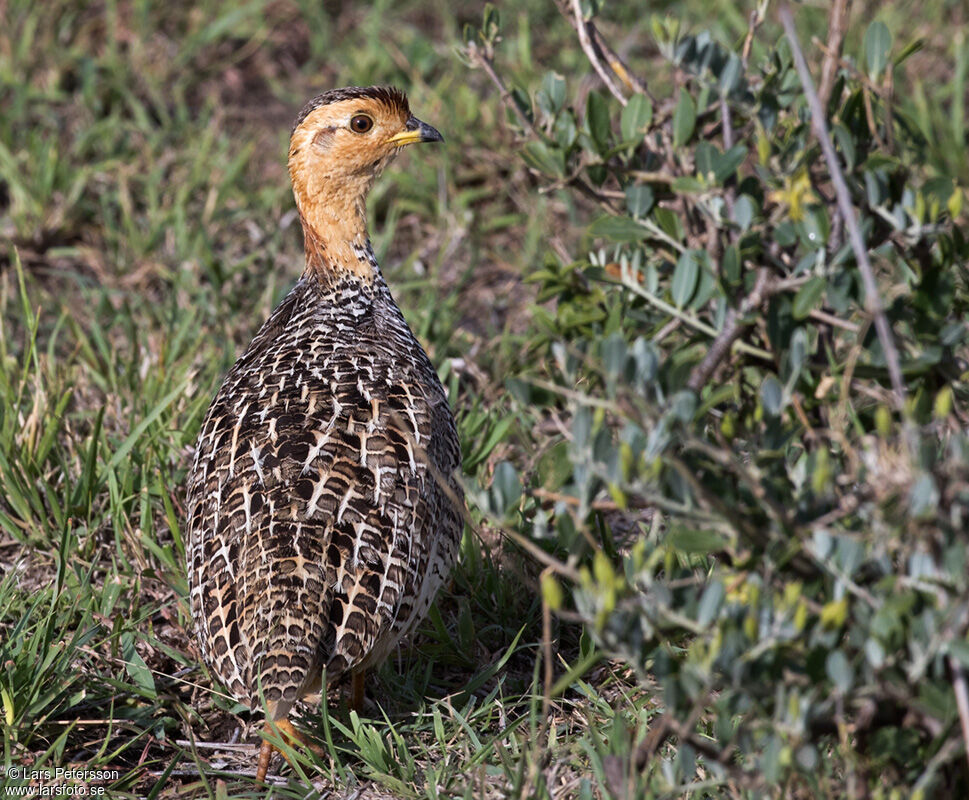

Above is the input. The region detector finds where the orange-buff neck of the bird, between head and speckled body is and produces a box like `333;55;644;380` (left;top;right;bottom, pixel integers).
294;176;376;284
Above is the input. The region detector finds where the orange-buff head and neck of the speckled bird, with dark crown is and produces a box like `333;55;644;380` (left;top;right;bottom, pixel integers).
289;86;444;280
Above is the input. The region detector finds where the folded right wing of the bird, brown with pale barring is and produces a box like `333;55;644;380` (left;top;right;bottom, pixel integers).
305;380;456;676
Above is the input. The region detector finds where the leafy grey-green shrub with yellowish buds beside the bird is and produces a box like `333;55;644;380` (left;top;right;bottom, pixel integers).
463;2;969;796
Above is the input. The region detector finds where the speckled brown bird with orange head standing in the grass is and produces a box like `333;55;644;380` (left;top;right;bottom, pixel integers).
186;86;464;781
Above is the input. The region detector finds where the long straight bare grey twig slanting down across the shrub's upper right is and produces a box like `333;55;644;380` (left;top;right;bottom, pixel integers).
780;2;905;411
